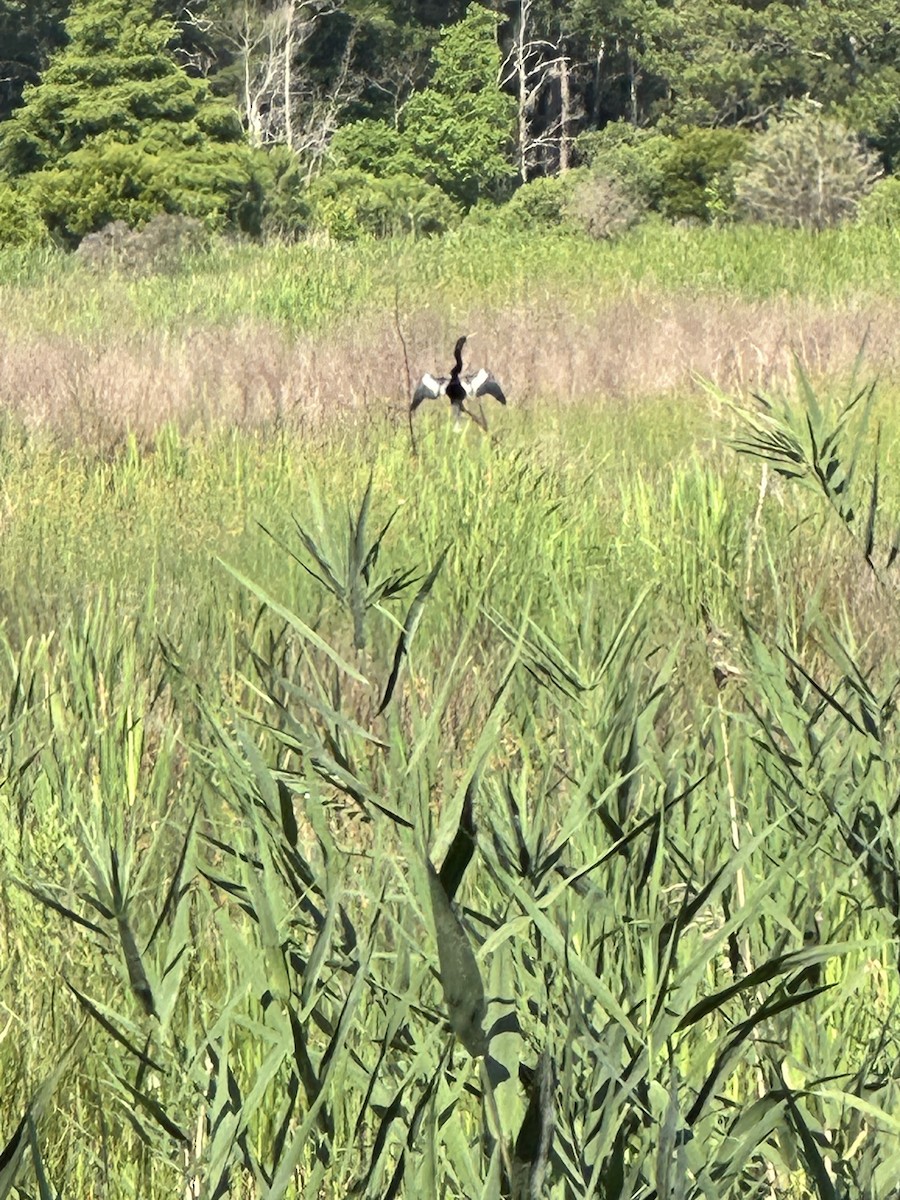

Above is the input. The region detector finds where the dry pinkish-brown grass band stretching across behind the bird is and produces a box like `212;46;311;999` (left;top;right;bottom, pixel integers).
0;294;900;444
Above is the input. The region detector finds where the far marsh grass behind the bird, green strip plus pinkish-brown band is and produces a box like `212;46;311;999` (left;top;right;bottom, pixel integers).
0;226;900;452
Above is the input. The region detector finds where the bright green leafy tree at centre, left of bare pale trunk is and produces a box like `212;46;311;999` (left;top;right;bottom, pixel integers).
400;4;516;208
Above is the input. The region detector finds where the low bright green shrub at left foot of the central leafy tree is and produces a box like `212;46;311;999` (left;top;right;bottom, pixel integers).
307;169;460;241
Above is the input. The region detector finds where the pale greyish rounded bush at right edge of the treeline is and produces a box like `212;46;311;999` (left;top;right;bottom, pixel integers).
736;107;880;229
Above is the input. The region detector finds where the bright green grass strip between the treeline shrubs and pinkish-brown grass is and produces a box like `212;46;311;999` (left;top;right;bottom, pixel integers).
0;222;900;335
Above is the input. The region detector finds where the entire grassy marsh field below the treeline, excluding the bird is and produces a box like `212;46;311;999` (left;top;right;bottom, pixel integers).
0;227;900;1200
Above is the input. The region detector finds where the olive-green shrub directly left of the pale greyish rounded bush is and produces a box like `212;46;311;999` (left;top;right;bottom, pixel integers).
659;128;748;223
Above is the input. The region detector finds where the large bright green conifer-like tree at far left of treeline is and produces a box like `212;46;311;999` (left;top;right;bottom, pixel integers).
0;0;262;240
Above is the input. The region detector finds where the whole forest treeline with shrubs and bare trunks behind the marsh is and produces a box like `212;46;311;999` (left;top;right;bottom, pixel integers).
0;0;900;252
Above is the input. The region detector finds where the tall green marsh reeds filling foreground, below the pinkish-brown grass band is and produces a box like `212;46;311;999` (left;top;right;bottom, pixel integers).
0;367;900;1196
